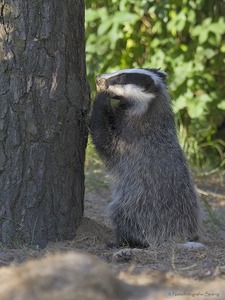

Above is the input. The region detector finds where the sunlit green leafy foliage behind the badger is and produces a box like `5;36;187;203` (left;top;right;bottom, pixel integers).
86;0;225;169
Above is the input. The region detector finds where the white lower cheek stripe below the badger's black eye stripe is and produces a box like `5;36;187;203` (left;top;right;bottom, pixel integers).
108;84;155;116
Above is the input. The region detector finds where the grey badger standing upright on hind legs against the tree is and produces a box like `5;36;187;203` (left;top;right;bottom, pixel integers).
90;69;200;247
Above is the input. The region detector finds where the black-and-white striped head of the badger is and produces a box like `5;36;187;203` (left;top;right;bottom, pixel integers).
96;69;166;115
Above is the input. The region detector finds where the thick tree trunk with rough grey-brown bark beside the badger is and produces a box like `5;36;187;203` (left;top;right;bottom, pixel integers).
0;0;89;247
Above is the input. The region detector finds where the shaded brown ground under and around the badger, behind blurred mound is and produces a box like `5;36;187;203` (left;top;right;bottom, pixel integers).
0;170;225;299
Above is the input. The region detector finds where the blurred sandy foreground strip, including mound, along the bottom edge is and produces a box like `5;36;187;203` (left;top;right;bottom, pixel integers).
0;251;225;300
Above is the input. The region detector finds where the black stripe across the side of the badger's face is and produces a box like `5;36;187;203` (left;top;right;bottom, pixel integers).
106;73;154;89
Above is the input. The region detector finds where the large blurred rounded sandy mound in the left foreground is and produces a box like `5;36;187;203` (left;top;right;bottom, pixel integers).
0;252;125;300
